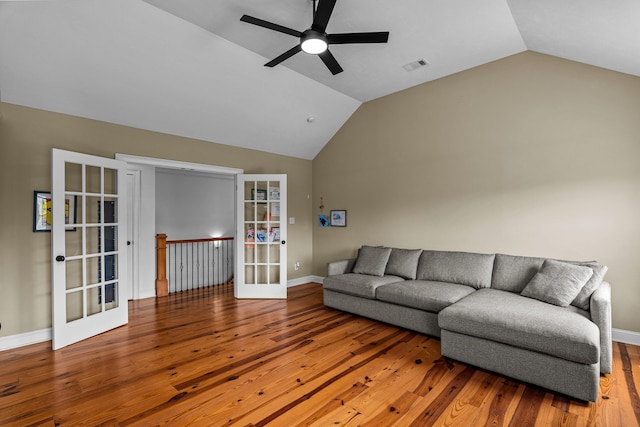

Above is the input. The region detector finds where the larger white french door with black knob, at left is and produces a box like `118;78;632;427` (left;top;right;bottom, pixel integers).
51;149;128;350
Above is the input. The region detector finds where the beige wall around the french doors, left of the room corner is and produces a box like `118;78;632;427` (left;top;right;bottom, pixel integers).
0;103;312;337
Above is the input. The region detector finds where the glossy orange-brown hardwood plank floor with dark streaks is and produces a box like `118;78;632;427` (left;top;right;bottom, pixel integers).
0;284;640;427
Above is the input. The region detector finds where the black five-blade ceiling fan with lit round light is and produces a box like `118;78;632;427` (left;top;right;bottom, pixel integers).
240;0;389;75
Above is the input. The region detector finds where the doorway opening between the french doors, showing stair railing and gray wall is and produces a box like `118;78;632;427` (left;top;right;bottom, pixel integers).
156;168;235;295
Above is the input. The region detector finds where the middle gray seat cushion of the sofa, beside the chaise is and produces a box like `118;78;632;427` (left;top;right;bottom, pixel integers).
376;280;475;313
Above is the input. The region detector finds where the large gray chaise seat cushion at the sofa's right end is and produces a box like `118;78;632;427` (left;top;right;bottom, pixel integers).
438;289;600;364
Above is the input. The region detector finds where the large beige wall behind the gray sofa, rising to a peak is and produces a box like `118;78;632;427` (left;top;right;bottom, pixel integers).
313;52;640;332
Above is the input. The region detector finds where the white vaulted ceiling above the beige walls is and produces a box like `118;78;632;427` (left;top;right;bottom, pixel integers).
0;0;640;159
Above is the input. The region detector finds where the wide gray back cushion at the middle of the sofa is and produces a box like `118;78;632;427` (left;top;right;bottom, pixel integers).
417;251;494;289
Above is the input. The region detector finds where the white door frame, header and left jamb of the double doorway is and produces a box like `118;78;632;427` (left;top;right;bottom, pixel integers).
115;153;244;299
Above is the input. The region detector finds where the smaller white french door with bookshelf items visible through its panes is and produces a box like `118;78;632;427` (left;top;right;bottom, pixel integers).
234;175;287;298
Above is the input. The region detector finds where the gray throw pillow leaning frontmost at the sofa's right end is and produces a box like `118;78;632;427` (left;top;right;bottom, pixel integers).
520;259;593;307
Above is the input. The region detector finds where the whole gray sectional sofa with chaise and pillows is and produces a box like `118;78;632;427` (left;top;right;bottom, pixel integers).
323;246;612;401
